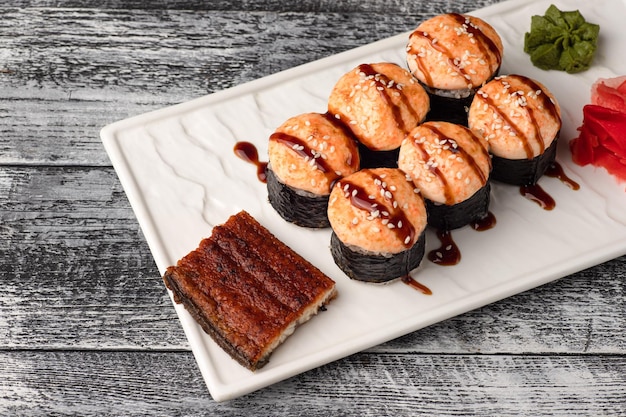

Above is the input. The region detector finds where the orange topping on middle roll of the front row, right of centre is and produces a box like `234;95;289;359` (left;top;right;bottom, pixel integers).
398;122;491;205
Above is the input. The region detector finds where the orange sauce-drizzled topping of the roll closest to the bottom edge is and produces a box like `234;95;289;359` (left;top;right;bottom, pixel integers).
328;168;426;253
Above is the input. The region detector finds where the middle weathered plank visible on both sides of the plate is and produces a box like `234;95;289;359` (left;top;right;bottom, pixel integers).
0;167;626;353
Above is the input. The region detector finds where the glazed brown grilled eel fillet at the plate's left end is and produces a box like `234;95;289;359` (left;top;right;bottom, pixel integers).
163;211;336;371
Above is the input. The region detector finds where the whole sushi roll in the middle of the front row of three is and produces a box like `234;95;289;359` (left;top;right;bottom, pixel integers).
398;122;491;230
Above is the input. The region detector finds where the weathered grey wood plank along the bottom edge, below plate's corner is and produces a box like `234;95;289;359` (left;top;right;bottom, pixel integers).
0;352;626;417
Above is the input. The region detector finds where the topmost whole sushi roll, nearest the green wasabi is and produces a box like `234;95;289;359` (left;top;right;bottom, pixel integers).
407;13;503;126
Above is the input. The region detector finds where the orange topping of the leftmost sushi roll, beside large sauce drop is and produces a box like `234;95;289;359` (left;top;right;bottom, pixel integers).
268;113;360;195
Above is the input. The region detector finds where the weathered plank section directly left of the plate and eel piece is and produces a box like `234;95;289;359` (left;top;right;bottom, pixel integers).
0;168;186;349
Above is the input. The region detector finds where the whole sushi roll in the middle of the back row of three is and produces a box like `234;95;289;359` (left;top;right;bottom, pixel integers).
328;62;429;168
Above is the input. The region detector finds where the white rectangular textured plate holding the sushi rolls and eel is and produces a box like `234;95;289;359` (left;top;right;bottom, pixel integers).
101;0;626;401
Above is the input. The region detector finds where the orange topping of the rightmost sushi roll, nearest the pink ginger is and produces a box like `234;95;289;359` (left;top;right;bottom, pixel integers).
468;75;561;159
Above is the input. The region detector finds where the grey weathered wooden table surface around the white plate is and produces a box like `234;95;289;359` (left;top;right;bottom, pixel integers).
0;0;626;416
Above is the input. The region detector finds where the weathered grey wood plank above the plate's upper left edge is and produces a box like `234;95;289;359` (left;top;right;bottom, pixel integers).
0;4;502;165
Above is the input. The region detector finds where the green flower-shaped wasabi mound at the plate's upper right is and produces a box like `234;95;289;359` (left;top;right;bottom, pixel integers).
524;5;600;74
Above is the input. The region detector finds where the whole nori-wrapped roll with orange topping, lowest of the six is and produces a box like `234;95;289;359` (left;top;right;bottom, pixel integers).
328;168;426;283
